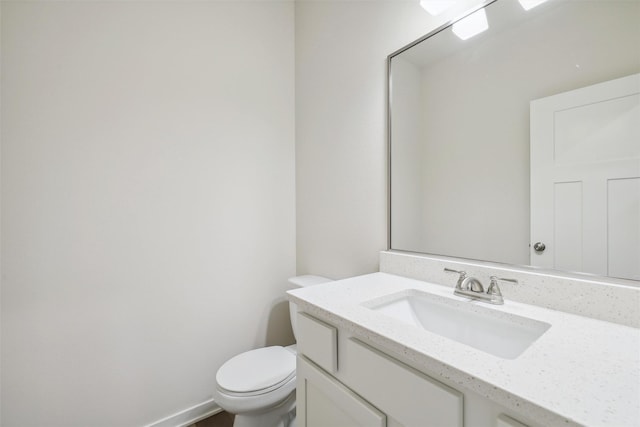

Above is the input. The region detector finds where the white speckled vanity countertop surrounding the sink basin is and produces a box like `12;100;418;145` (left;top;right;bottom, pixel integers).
288;273;640;427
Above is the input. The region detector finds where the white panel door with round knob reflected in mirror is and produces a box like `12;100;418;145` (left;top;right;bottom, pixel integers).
531;74;640;280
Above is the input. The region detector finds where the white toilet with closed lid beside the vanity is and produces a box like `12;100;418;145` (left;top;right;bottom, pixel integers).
214;275;331;427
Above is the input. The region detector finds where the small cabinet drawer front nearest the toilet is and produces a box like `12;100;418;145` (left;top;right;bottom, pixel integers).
296;313;338;373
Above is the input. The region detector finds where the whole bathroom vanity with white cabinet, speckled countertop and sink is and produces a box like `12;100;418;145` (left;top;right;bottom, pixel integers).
288;273;640;427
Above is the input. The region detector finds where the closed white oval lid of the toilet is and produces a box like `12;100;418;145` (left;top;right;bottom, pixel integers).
216;346;296;393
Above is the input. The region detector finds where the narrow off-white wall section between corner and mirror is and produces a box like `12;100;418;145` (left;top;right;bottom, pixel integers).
295;0;444;278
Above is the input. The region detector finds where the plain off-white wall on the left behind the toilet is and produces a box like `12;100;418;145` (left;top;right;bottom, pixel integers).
1;1;296;427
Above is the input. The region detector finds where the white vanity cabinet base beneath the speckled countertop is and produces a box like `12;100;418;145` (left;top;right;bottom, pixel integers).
297;313;527;427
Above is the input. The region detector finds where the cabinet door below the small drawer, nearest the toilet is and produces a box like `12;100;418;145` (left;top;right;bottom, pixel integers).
296;356;387;427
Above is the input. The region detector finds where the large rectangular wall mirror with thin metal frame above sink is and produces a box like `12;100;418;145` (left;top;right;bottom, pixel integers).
388;0;640;281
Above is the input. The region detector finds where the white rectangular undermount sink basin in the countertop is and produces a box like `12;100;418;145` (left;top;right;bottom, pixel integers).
363;290;551;359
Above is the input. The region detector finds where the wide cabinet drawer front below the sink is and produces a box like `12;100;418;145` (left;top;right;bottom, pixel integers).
340;338;463;427
